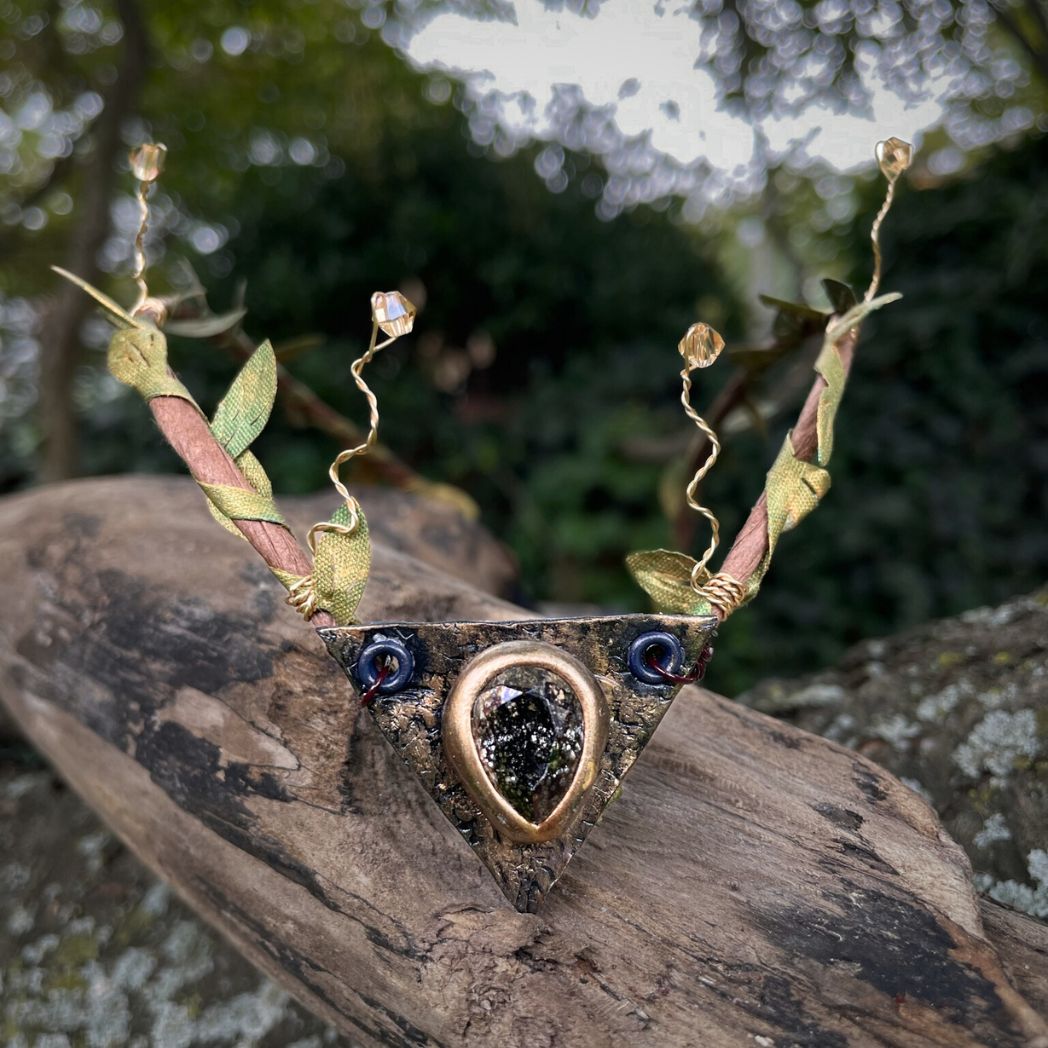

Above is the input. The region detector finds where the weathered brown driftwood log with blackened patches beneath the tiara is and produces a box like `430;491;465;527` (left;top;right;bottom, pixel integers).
0;478;1048;1048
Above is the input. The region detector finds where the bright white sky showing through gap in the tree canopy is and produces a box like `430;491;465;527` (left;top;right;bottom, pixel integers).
408;0;943;203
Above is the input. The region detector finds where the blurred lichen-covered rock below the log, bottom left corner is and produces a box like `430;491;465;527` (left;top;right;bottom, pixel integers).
0;761;345;1048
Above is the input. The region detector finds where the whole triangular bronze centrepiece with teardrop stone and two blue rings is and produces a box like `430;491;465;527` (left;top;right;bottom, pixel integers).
320;615;717;912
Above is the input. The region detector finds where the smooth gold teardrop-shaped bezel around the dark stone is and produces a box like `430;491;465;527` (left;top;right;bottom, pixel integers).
442;640;610;844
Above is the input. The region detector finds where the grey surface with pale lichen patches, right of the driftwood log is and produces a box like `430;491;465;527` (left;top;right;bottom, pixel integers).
741;588;1048;917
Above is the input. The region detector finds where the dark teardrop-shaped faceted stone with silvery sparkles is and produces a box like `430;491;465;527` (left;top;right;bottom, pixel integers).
473;665;584;823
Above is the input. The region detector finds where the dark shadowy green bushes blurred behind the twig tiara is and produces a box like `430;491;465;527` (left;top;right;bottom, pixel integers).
88;122;1048;693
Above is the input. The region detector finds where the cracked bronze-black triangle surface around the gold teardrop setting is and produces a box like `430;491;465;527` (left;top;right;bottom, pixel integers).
320;615;717;912
